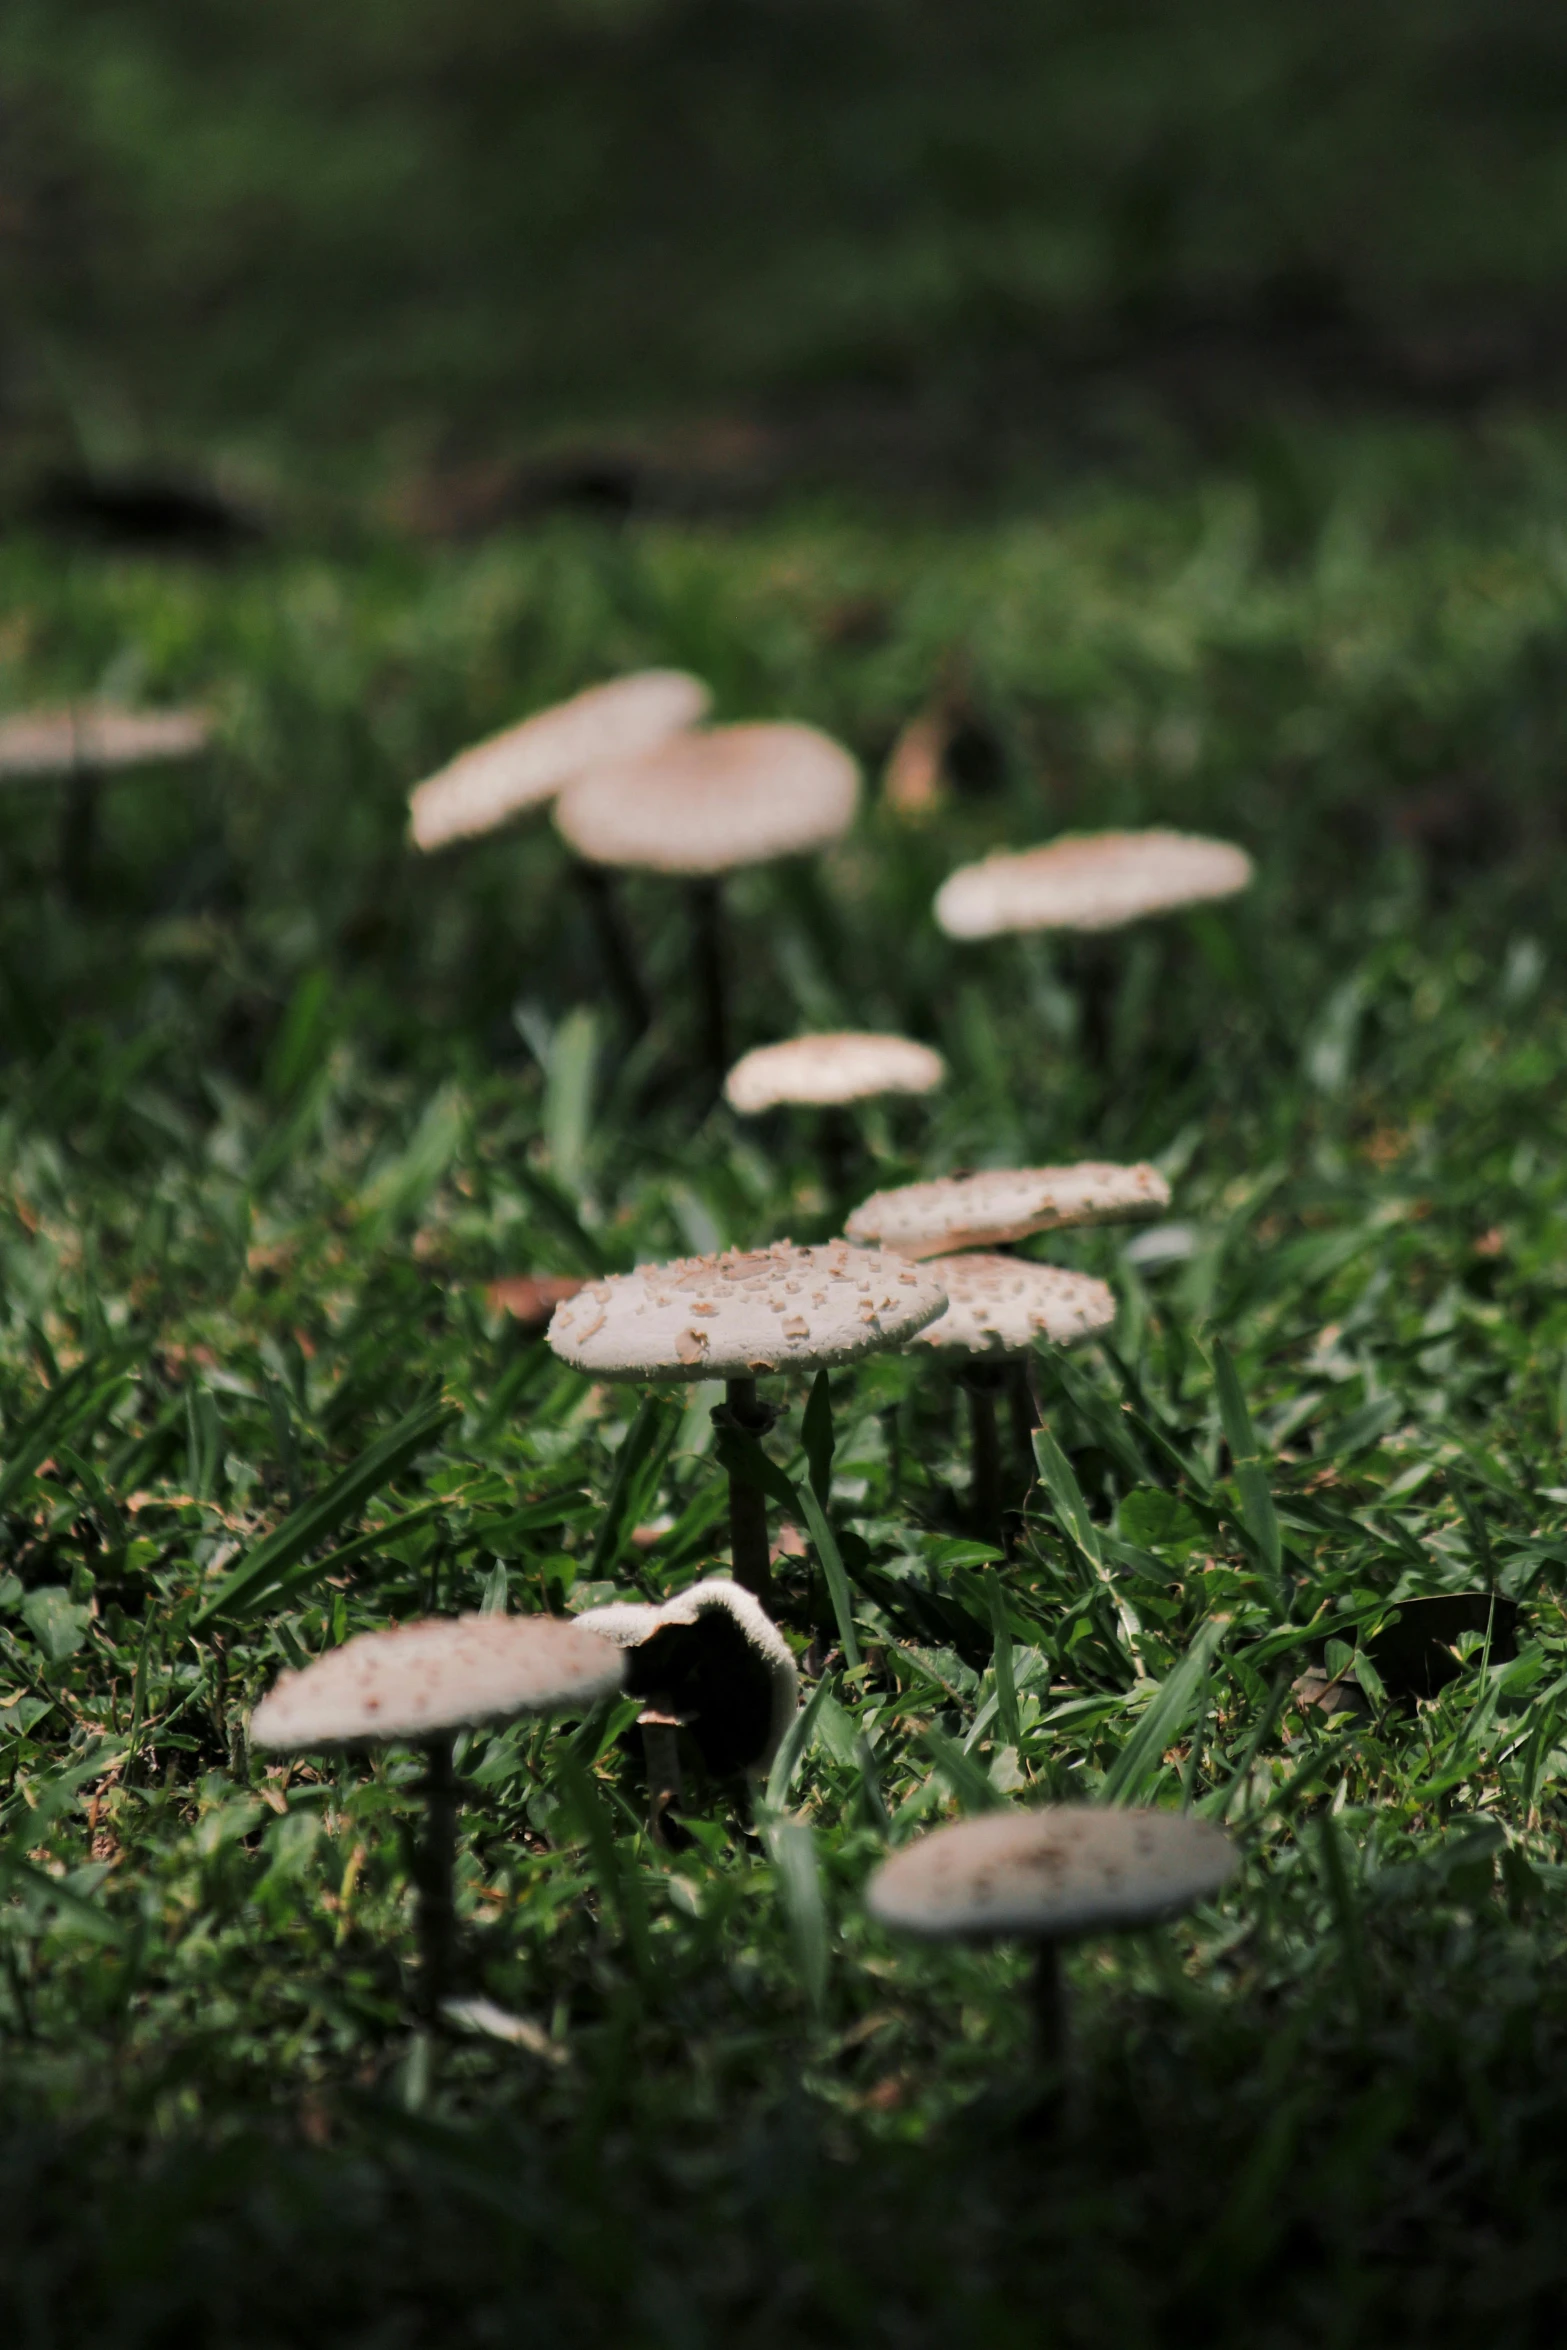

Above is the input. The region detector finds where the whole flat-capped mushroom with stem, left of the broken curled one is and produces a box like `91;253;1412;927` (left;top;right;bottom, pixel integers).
251;1614;625;2021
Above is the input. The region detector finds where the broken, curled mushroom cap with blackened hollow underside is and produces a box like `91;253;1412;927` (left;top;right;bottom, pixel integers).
576;1575;799;1772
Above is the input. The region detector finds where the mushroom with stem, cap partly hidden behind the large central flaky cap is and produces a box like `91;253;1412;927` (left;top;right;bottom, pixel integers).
912;1255;1116;1549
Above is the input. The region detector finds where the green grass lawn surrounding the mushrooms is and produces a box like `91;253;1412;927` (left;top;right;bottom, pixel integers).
0;428;1567;2350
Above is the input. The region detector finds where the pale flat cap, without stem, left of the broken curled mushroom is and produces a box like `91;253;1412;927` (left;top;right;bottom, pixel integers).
251;1614;625;1751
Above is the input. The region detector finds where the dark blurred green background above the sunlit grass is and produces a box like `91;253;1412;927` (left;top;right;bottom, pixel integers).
0;0;1567;529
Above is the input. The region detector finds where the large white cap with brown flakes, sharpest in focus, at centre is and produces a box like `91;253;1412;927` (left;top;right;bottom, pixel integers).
550;1241;947;1382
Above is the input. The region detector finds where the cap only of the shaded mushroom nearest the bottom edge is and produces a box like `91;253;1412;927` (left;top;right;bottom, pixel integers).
867;1802;1236;1941
